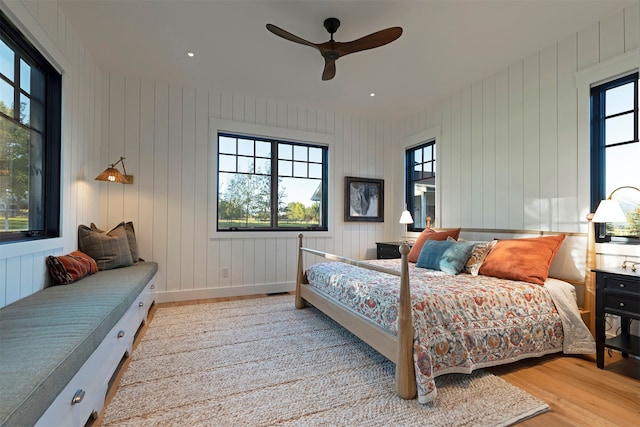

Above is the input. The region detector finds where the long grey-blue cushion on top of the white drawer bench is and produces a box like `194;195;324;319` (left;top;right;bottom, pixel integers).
0;262;158;425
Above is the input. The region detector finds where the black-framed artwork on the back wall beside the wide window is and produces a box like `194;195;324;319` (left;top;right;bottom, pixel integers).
344;176;384;222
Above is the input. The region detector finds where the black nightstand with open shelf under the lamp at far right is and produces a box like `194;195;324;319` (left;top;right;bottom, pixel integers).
593;267;640;368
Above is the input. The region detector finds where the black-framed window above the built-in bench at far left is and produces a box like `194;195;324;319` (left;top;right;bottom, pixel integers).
0;12;62;241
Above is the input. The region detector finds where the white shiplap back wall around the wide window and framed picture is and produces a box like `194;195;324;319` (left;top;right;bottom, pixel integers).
97;82;392;301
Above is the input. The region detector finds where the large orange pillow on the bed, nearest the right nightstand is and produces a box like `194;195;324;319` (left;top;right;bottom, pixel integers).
479;234;564;286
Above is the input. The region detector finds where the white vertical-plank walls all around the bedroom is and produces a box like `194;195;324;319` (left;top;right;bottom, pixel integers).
0;0;640;306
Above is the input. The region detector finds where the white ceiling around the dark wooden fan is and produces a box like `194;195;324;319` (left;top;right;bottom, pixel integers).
61;0;637;119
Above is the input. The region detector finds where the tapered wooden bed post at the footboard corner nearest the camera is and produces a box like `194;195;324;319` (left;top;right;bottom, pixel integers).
396;242;416;399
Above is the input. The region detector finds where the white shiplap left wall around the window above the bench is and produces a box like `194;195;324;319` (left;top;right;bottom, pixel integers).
0;0;104;307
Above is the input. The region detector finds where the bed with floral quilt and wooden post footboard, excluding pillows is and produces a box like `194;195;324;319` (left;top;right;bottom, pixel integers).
296;235;595;403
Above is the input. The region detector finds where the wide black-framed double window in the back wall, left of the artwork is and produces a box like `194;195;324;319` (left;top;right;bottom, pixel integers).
217;133;328;231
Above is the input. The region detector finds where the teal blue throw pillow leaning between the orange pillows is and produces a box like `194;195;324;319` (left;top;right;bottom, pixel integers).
416;240;473;274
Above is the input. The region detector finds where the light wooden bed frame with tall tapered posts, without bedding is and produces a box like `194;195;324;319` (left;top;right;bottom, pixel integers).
295;221;595;399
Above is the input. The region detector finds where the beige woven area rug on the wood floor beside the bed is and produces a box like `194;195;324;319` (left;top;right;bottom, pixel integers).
103;295;549;426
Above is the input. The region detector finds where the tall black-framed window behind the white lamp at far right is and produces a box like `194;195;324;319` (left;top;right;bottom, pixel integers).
591;73;640;243
